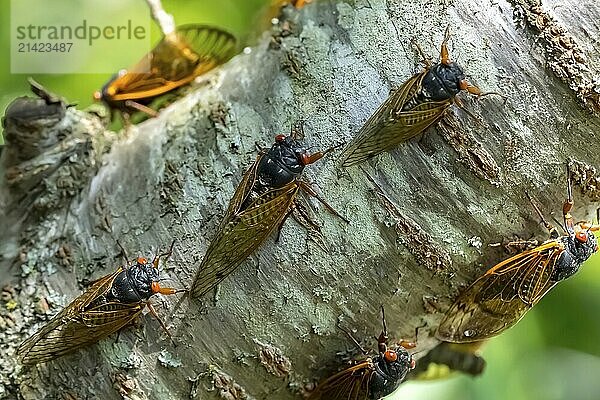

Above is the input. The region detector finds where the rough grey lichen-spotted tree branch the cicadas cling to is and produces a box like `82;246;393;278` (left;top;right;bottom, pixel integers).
0;0;600;399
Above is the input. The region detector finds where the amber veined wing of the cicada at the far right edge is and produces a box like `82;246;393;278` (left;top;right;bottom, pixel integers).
436;241;564;343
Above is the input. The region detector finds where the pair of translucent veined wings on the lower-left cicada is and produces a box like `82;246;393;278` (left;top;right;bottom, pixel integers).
17;269;144;365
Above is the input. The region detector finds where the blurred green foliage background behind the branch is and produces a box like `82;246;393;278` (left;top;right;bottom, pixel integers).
0;0;600;400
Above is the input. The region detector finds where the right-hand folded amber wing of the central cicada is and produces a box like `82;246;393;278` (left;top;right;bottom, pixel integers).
191;182;299;297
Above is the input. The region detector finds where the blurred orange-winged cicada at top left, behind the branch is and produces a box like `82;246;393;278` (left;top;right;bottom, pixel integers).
94;25;237;119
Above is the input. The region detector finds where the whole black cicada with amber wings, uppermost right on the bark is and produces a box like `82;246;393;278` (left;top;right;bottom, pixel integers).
341;29;482;167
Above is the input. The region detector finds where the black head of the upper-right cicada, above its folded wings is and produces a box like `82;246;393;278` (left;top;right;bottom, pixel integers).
422;61;467;101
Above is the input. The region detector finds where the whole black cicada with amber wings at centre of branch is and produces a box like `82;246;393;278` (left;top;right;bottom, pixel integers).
191;129;348;298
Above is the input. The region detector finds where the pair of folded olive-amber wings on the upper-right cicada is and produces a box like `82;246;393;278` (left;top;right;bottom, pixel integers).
341;71;452;167
